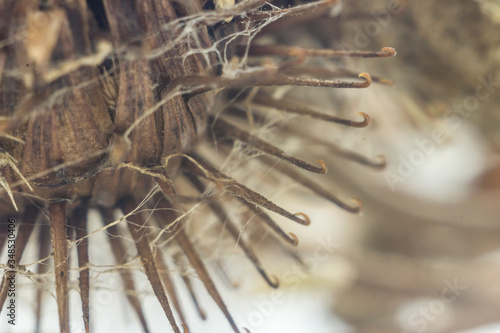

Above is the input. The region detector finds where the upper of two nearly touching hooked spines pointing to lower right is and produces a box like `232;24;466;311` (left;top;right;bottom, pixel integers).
183;154;311;225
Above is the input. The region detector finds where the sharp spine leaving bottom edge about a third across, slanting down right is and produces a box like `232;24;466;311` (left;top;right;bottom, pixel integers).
119;198;180;333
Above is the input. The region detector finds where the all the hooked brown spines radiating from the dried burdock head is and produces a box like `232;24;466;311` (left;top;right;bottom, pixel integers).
0;0;395;333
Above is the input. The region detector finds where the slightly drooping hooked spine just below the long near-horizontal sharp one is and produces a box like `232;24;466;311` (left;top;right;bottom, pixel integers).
252;94;370;128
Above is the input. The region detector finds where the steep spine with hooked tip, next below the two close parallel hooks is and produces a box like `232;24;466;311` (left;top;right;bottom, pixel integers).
185;173;279;288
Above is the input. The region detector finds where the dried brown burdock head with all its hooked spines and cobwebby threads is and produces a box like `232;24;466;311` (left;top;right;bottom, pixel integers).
0;0;396;332
